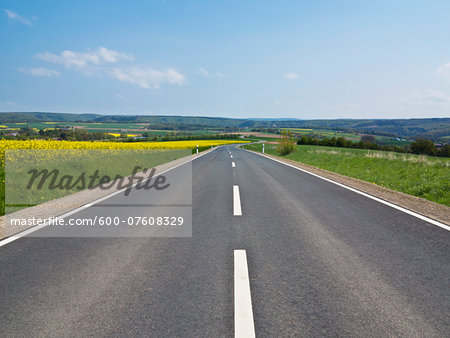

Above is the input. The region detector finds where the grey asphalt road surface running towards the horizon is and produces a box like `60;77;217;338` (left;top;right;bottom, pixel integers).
0;147;450;337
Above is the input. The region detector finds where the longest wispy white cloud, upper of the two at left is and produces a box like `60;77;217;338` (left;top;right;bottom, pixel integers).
35;47;134;68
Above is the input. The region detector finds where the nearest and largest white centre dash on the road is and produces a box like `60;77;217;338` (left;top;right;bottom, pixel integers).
234;250;255;338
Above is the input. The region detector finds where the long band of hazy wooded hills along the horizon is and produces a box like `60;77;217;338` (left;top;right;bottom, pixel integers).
0;112;450;142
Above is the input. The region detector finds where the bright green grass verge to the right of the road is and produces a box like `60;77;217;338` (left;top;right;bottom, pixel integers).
244;144;450;206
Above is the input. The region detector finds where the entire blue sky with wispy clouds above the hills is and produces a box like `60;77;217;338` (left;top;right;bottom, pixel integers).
0;0;450;119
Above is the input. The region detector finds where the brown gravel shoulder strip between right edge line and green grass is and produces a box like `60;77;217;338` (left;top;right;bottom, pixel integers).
248;150;450;225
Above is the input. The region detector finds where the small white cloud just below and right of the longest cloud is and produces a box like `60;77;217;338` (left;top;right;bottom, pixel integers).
112;67;185;88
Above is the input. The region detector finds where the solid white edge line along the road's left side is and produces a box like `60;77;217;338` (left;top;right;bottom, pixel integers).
0;148;217;247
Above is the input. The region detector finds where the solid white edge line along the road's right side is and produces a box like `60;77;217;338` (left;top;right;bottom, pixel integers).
241;148;450;231
